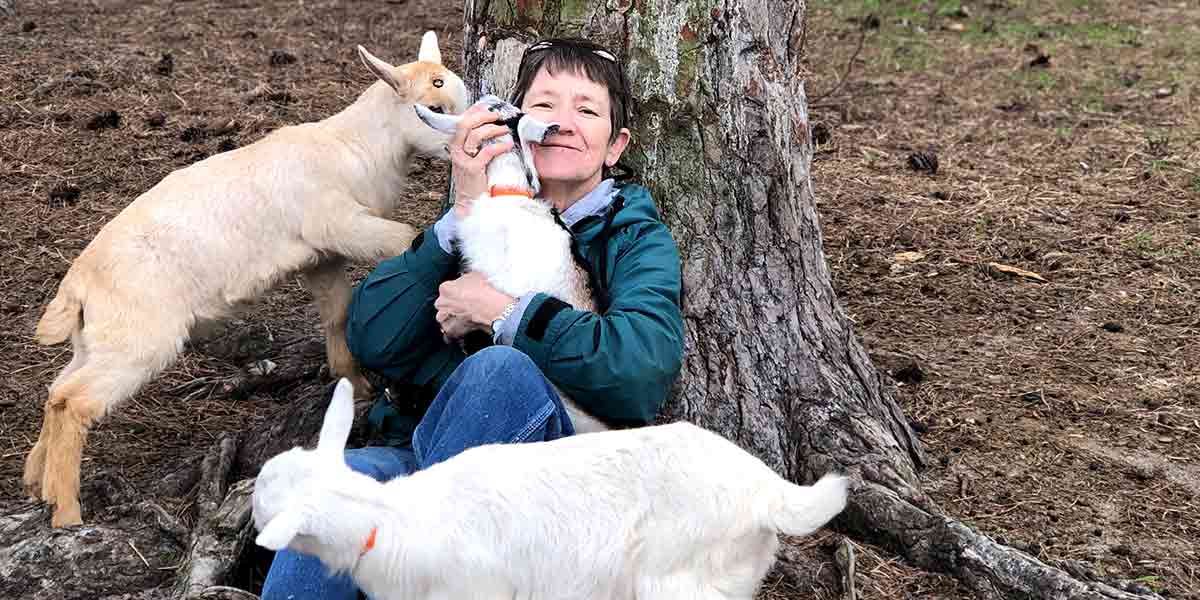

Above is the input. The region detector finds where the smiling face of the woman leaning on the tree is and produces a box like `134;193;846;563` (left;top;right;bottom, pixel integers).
521;67;629;202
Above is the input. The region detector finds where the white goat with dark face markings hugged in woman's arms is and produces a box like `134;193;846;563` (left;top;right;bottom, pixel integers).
415;95;608;433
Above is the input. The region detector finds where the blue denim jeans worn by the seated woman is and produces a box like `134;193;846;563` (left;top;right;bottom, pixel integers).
262;346;575;600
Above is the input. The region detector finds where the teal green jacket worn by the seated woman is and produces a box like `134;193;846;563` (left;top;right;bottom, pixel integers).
347;184;683;443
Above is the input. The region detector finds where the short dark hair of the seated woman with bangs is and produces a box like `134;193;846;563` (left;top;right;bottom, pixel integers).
511;37;631;142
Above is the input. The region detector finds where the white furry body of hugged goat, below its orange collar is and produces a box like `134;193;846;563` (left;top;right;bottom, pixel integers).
458;197;575;302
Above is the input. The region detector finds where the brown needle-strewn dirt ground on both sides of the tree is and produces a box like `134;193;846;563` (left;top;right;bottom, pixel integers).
0;0;1200;599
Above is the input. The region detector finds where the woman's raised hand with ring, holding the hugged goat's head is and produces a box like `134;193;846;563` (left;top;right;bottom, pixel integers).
450;104;512;221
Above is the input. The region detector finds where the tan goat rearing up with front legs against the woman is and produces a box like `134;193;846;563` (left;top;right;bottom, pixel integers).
24;31;467;527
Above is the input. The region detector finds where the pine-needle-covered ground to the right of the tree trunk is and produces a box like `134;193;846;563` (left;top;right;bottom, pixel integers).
806;2;1200;598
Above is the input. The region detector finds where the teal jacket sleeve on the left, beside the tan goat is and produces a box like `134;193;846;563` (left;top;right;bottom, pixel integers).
346;226;461;385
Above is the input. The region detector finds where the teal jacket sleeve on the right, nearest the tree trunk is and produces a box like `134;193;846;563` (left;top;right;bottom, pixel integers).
512;223;684;425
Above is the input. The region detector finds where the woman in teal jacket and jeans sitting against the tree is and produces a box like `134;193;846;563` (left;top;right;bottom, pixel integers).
263;40;683;600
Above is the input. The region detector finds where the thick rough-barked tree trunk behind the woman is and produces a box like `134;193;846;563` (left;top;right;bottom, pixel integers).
463;0;1153;599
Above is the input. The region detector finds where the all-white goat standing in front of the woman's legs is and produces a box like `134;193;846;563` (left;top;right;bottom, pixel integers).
252;379;847;600
